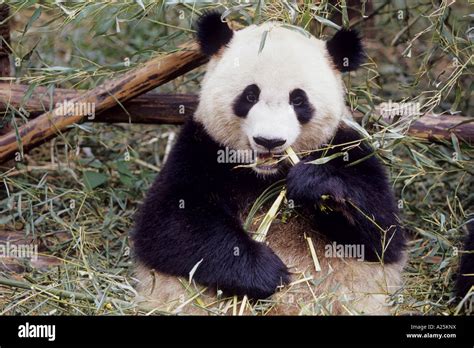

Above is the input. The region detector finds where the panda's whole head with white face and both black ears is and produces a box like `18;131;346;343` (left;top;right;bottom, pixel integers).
195;12;363;174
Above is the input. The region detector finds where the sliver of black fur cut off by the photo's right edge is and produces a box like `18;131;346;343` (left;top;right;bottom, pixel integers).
456;220;474;298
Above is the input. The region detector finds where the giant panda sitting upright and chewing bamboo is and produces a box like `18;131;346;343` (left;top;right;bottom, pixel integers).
131;12;406;315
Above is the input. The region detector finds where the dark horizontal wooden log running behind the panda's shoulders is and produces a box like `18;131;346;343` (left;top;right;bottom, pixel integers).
0;83;474;144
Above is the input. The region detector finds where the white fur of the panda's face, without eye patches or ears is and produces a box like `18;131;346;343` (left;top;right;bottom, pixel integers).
195;22;346;155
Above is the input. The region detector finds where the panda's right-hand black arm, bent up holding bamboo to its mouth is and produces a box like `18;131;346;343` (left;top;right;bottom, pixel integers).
287;128;404;263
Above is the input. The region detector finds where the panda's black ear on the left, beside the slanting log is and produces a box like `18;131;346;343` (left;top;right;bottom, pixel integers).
197;11;234;56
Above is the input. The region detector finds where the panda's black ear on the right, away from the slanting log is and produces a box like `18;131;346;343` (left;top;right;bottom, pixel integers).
326;29;364;72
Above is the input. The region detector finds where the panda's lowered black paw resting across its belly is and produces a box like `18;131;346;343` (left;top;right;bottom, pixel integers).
219;243;290;300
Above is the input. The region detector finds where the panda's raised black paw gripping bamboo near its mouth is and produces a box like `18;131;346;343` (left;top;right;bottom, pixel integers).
286;162;353;205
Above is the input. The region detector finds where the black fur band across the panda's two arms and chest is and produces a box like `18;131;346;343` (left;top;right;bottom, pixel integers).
132;120;403;298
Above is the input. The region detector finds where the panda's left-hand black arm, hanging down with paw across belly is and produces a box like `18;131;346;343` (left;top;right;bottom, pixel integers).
132;120;289;298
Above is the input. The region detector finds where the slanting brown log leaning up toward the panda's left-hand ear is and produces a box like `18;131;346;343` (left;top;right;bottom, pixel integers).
0;44;207;163
